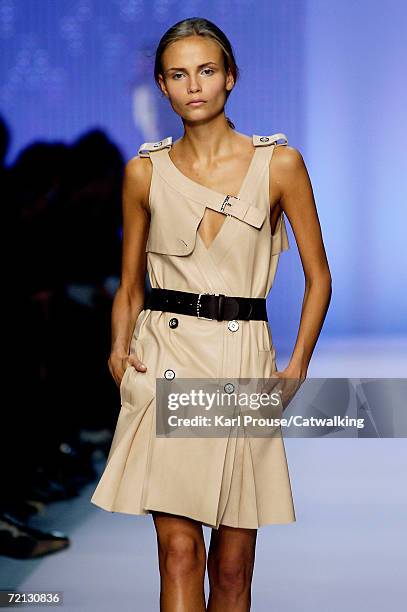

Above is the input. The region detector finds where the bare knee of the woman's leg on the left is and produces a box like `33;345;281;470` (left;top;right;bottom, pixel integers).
160;534;206;578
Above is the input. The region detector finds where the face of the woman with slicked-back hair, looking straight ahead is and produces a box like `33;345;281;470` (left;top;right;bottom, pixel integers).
159;36;234;122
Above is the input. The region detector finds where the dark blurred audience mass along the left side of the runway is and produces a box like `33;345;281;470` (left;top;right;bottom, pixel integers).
0;118;143;559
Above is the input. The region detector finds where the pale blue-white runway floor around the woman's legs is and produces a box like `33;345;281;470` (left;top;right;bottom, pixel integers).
0;338;407;612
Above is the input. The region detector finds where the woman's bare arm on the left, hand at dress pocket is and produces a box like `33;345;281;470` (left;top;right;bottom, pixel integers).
109;157;152;385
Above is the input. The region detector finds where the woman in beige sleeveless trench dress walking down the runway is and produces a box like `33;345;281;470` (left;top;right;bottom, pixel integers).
91;18;331;612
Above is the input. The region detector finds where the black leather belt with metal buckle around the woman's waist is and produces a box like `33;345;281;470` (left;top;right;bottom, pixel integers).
144;287;268;321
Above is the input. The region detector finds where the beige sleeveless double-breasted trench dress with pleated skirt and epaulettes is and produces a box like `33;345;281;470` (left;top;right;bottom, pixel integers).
91;133;296;529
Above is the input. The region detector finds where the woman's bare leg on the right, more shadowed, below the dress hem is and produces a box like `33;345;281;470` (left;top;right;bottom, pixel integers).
207;525;257;612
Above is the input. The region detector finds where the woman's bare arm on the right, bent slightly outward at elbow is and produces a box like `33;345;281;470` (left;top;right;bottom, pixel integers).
270;146;332;378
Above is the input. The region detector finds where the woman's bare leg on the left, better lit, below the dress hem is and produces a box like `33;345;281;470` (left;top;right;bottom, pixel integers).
152;511;206;612
